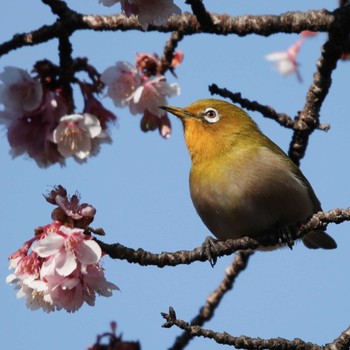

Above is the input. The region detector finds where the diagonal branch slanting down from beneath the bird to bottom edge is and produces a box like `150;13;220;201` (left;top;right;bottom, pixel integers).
169;251;252;350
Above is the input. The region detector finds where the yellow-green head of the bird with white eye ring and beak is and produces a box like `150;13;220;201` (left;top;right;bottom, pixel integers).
161;99;260;159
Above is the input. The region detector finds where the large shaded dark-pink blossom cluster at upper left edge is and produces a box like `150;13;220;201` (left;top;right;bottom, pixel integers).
0;61;116;167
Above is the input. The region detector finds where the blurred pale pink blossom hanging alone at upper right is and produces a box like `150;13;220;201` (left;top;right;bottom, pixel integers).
265;30;317;81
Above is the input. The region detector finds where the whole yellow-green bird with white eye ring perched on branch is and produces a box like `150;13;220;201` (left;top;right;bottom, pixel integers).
161;99;337;250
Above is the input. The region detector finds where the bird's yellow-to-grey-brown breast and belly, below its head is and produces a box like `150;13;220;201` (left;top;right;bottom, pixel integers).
190;147;314;239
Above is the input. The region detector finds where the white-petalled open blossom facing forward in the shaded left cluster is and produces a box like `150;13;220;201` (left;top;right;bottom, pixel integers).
52;113;107;159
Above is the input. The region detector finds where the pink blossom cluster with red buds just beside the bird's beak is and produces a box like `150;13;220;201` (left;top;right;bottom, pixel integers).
101;51;183;138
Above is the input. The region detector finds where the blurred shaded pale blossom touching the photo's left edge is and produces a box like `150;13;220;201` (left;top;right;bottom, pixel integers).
0;67;43;112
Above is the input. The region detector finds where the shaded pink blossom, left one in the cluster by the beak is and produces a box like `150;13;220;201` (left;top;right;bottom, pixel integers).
101;62;141;107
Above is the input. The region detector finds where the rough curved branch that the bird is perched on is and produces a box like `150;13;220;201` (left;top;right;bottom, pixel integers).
96;208;350;267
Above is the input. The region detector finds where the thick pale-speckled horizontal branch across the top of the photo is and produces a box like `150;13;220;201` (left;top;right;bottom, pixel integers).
80;10;345;36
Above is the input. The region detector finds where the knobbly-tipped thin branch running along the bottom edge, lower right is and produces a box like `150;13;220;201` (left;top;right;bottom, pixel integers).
162;308;322;350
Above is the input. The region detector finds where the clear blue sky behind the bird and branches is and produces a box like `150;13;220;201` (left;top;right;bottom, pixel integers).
0;0;350;350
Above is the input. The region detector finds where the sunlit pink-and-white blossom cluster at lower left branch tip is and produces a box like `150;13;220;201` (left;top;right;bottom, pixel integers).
6;186;118;312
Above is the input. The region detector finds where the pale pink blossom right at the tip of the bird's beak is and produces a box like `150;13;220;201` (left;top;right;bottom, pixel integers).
129;75;180;117
